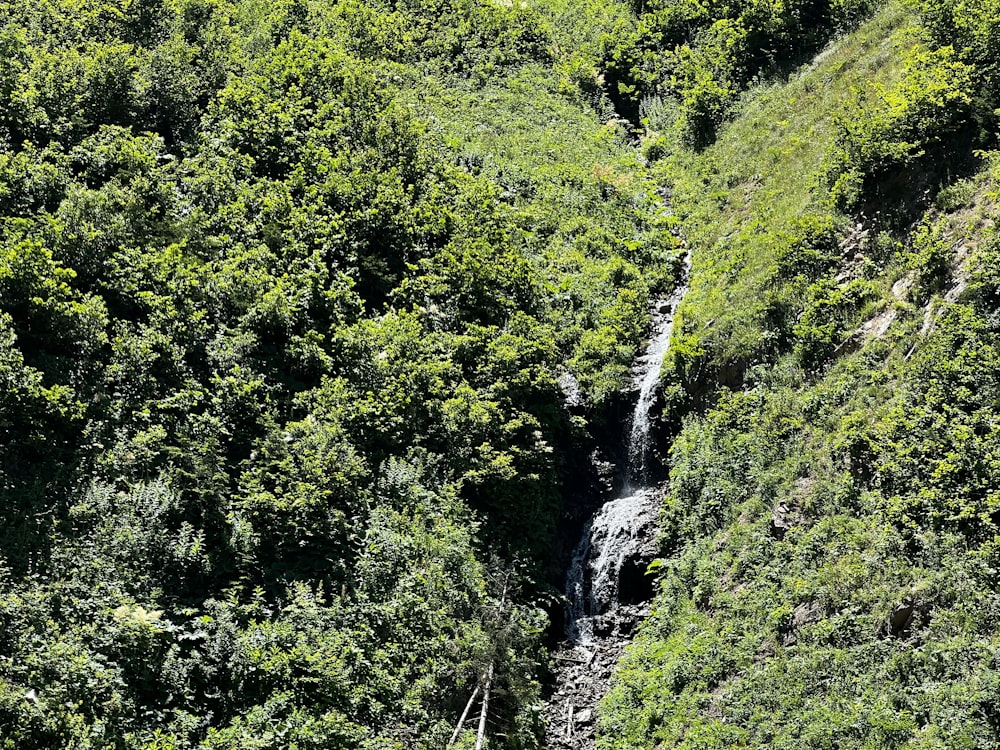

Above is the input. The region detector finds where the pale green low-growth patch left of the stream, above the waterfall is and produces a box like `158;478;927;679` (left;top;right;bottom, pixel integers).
411;66;680;401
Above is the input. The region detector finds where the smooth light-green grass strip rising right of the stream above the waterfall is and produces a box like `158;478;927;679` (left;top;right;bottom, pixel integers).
654;3;916;364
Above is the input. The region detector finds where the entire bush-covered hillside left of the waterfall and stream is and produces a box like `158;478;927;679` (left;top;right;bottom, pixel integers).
0;0;677;750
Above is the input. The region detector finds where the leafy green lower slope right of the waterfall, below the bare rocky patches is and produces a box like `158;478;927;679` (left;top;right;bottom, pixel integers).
603;304;997;748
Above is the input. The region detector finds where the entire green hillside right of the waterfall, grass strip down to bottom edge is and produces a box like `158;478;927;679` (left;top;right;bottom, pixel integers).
599;5;1000;749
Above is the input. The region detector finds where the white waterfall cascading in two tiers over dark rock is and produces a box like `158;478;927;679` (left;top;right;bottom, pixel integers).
566;256;690;645
